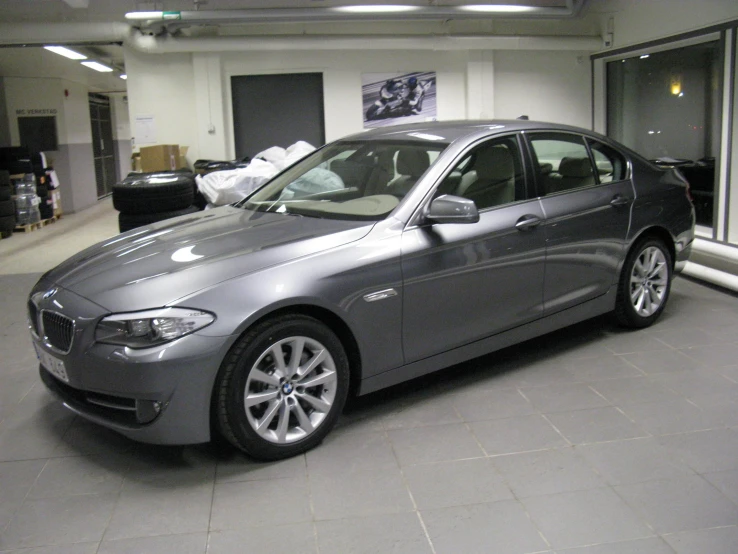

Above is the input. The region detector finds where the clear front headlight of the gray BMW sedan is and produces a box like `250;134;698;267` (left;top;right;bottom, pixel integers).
95;308;215;348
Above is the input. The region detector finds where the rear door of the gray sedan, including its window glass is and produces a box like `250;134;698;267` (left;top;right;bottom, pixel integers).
526;132;635;314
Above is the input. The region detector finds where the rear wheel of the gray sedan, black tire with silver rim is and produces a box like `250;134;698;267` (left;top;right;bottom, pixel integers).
614;237;674;329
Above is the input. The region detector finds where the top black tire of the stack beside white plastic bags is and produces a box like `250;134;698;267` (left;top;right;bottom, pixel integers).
113;173;194;215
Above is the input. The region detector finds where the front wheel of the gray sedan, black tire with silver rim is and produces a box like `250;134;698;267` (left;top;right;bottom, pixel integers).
213;315;349;460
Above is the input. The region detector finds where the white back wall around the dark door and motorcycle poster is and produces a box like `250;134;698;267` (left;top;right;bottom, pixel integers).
126;48;591;162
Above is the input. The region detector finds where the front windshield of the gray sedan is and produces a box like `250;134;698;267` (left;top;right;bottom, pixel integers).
241;140;448;221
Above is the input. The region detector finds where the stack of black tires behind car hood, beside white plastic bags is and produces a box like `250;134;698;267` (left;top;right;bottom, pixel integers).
113;171;199;233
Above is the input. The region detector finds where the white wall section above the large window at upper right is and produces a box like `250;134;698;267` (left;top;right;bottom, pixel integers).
587;0;738;48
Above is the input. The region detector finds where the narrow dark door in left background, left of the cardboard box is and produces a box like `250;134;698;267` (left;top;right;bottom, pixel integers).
89;93;118;198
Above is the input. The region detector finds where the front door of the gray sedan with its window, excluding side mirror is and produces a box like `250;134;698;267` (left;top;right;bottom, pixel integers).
402;135;545;362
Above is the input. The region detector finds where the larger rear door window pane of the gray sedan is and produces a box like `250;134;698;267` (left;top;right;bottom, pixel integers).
530;133;597;196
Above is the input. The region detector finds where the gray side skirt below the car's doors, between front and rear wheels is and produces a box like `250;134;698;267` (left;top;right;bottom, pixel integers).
358;287;617;396
